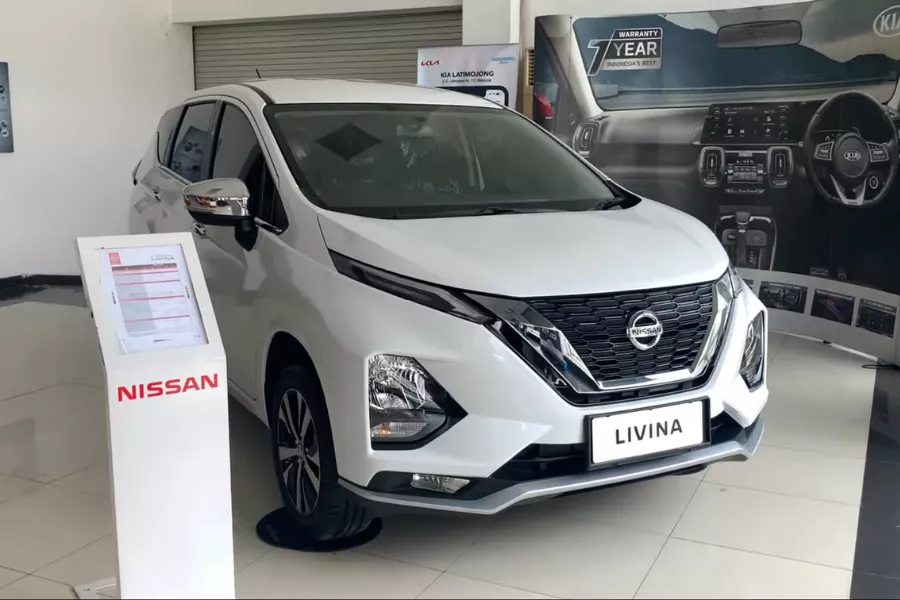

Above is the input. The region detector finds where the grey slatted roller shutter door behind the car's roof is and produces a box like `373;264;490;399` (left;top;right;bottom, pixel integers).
194;10;462;89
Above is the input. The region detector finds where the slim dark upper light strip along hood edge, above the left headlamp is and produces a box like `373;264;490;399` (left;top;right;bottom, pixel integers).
331;252;490;323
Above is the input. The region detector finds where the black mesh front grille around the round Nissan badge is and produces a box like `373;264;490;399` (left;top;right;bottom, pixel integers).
527;283;714;381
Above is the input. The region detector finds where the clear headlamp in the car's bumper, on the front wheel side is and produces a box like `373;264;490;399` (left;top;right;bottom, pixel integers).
369;354;448;443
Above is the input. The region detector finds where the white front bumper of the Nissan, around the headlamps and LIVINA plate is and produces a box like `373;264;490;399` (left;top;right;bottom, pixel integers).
307;276;768;496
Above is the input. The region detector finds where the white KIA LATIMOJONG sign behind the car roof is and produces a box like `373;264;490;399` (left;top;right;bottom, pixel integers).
417;44;519;109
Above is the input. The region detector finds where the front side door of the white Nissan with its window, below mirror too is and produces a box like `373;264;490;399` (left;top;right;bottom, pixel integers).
192;102;277;398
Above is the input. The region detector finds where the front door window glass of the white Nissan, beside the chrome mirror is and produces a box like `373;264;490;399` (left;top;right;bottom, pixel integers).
212;104;287;229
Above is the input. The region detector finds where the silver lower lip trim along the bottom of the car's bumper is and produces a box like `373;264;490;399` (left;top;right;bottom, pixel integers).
340;416;765;515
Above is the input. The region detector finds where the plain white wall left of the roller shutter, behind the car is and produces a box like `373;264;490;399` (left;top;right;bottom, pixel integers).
0;0;193;278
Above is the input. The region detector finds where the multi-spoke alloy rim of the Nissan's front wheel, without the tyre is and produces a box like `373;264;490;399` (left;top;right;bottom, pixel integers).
277;389;322;516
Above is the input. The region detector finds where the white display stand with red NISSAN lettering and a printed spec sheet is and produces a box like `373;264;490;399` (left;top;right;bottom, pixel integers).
75;233;235;598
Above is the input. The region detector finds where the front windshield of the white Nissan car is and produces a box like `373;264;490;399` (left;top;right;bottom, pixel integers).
267;104;613;218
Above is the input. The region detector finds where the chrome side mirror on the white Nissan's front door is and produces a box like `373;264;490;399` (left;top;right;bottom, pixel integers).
183;178;253;225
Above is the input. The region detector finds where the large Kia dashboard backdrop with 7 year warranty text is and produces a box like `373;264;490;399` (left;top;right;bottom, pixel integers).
532;0;900;361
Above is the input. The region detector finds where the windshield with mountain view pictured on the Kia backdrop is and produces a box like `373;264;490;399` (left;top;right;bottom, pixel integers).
573;0;900;109
